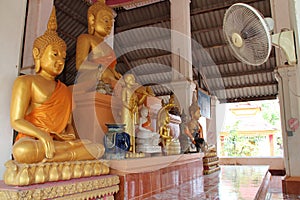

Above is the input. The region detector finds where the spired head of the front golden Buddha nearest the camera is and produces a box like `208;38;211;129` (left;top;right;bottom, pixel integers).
32;7;67;75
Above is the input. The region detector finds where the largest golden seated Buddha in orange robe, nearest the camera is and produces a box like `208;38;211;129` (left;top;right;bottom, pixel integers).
10;9;104;164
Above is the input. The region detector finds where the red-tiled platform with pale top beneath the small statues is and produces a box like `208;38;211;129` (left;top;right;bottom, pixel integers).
110;153;204;199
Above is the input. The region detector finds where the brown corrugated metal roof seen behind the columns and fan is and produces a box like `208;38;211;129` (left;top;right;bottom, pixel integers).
48;0;278;102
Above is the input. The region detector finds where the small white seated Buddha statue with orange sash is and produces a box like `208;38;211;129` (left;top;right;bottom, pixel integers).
136;106;161;153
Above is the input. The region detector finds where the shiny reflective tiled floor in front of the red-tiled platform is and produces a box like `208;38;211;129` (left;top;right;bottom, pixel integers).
142;166;300;200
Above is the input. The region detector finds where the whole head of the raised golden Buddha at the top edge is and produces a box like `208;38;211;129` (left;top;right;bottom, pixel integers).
87;0;115;38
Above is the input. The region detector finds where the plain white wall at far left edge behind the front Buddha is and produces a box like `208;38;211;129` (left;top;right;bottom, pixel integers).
0;0;26;175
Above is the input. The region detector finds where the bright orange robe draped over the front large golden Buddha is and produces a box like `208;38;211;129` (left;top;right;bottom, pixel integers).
16;81;72;141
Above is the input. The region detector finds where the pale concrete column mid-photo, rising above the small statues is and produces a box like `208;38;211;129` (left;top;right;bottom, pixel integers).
170;0;195;116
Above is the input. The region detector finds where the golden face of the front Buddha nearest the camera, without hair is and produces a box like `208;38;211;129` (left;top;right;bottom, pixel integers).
40;44;66;76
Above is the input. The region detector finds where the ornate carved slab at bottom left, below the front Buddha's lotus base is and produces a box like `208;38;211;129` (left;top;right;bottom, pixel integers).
0;175;120;200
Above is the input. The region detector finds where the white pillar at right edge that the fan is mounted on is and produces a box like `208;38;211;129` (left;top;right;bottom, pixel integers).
273;0;300;177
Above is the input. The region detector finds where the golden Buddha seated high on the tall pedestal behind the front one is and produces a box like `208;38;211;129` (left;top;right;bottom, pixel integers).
76;0;121;88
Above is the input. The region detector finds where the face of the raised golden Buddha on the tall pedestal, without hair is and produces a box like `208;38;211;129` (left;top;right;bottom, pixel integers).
94;10;113;37
